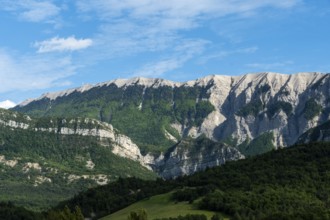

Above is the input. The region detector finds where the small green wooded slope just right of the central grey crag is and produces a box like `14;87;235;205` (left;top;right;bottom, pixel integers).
237;132;275;156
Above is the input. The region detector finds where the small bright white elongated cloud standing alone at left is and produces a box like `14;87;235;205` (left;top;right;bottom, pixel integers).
34;36;93;53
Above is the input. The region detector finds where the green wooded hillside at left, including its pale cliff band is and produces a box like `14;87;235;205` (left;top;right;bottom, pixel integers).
0;109;156;209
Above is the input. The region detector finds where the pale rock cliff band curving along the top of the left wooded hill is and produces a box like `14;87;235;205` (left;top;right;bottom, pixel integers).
0;110;151;169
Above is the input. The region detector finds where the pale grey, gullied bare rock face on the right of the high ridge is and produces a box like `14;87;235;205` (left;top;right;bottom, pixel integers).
208;73;330;146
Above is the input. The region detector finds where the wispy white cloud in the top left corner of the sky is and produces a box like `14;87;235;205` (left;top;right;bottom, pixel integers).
0;0;61;22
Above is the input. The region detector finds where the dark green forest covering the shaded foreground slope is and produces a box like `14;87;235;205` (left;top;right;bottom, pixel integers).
2;143;330;219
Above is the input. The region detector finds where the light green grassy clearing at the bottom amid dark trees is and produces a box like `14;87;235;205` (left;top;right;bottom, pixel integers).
101;193;223;220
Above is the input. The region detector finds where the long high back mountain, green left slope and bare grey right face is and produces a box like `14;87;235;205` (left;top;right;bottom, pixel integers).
14;73;330;155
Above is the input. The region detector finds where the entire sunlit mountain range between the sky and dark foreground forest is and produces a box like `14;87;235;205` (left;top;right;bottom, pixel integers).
0;73;330;208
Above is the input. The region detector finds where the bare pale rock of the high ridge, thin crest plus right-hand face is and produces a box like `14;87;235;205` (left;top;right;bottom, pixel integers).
18;72;330;146
